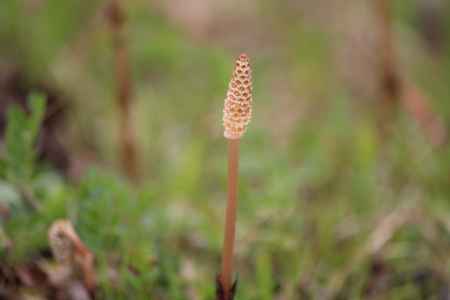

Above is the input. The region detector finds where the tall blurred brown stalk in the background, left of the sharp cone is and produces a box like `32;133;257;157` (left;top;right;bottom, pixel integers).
107;0;138;179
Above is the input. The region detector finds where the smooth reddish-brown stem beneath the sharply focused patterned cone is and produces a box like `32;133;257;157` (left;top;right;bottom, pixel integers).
220;139;239;299
